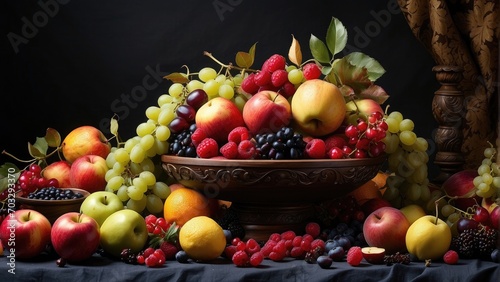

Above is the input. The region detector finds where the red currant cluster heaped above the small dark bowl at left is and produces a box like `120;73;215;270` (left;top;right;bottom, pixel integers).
0;164;59;200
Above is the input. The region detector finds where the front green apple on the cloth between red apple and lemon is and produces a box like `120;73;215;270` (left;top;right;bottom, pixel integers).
100;209;148;257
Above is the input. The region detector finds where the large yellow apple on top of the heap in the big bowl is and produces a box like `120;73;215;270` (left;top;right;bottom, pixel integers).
291;79;346;137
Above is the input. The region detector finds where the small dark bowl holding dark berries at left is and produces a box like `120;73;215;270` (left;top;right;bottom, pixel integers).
16;188;90;224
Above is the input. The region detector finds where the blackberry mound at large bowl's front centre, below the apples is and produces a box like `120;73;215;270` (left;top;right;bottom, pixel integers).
255;127;306;160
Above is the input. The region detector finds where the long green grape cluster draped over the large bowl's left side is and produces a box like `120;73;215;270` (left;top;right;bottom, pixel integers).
105;64;248;214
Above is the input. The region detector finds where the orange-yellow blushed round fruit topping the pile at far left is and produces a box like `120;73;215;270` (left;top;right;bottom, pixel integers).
62;125;111;163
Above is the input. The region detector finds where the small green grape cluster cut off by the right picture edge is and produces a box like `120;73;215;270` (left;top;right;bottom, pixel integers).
473;144;500;198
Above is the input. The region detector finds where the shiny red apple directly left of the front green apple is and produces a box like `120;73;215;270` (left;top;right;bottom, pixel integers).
50;212;100;262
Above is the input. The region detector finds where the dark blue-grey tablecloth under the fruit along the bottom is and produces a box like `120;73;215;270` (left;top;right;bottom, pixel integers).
0;254;500;282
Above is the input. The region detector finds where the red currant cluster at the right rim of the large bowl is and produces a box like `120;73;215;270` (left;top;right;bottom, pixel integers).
342;112;388;158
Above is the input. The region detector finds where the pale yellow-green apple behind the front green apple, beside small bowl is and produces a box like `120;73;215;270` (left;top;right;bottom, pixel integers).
80;191;123;226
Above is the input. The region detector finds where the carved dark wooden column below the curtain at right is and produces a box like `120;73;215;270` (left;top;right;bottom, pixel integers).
432;66;466;183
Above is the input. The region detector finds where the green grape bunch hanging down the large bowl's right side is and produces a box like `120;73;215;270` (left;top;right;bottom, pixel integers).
383;111;432;211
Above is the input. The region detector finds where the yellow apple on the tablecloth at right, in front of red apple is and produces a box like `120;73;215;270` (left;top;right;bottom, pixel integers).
406;215;451;260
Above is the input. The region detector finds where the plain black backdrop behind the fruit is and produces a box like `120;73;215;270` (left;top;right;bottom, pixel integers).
0;0;439;167
